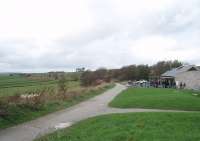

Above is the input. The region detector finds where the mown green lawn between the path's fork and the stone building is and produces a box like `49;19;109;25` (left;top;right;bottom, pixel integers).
109;88;200;111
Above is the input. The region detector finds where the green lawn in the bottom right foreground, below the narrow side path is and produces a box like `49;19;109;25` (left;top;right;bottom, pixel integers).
35;113;200;141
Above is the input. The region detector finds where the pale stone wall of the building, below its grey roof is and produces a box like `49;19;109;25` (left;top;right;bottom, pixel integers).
175;71;200;90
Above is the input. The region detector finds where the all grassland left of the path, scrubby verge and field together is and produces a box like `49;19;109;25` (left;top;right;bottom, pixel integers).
0;75;114;129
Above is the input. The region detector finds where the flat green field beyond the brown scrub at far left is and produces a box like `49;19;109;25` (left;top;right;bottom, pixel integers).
0;75;79;96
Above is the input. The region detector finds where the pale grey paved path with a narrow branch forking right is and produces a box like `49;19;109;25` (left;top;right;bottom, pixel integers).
0;84;191;141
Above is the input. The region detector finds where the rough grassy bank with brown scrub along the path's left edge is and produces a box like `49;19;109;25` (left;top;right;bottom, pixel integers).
0;84;114;129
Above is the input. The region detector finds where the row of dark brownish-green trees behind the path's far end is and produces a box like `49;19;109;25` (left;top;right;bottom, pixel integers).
80;60;183;86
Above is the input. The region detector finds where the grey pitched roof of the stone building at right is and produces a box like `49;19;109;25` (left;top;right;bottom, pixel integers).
161;65;200;77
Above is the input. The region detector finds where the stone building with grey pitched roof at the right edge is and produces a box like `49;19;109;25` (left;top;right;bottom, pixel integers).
161;65;200;90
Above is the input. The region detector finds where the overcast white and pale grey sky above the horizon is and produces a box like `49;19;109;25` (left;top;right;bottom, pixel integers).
0;0;200;72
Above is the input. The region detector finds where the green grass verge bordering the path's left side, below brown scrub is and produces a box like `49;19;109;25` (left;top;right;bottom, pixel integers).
0;84;114;129
